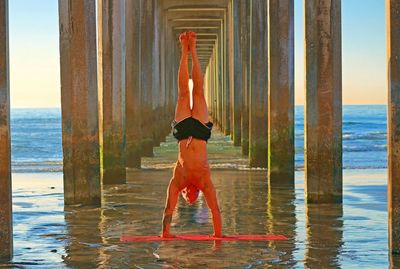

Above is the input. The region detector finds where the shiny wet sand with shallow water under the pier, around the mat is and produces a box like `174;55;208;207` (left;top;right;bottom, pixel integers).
0;130;398;268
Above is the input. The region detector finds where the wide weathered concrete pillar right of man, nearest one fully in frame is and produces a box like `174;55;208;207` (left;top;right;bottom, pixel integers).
304;0;343;202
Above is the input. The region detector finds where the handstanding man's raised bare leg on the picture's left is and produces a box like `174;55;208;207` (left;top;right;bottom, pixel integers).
175;33;192;122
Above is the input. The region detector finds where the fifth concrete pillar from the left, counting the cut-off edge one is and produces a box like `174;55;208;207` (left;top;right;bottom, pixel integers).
140;0;154;157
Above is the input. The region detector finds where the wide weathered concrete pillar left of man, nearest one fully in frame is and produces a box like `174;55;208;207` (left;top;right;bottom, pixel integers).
58;0;101;205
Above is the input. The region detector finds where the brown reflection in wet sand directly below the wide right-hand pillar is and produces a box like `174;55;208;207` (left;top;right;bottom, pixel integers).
304;204;343;268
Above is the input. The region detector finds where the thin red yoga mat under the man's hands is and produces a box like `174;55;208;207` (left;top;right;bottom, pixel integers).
120;234;287;242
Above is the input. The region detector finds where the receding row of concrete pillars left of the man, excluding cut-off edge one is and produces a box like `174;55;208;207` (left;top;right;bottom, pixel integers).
59;0;174;201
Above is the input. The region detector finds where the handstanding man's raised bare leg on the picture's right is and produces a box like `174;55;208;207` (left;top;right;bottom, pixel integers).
188;32;208;123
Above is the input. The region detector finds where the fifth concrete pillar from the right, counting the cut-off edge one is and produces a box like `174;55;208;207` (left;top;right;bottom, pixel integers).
240;0;251;156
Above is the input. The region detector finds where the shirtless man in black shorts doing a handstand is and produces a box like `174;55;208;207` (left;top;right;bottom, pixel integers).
162;32;222;237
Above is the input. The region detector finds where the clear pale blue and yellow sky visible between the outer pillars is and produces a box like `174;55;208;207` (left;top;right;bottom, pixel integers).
9;0;387;107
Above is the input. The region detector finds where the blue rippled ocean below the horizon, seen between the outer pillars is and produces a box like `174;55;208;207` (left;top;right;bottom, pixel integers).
11;105;387;172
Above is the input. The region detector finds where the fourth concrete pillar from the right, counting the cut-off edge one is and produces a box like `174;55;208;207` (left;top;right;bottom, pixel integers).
249;0;268;167
